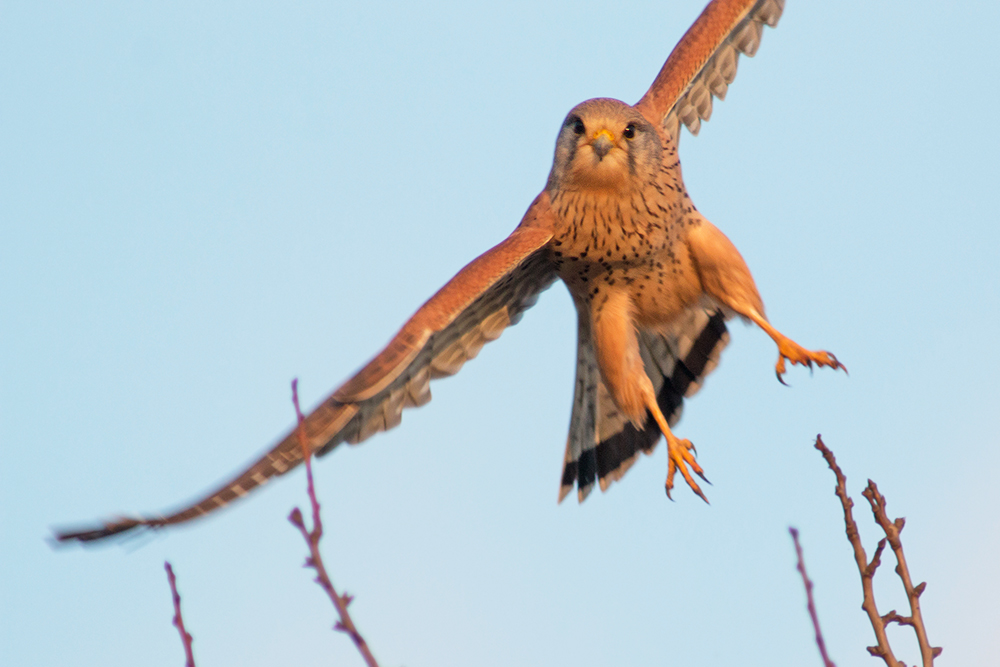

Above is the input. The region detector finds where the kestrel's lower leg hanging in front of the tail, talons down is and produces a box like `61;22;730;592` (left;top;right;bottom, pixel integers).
591;292;708;503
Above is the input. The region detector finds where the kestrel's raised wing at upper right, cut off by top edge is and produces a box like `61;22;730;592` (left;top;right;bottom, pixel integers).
635;0;785;137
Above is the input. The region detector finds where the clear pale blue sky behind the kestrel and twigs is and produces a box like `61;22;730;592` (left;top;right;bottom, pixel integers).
0;0;1000;667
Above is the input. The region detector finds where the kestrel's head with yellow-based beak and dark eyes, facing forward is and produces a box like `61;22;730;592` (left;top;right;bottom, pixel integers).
547;98;663;192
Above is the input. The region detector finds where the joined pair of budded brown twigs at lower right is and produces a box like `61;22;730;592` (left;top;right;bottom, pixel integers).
816;435;942;667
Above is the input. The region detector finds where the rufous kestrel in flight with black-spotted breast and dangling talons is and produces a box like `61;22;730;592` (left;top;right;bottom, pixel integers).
58;0;846;542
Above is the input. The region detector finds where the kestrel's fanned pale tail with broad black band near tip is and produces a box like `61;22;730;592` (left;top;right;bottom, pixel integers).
559;308;729;503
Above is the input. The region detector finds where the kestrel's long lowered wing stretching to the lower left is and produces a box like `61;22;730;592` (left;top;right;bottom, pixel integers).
56;193;556;542
